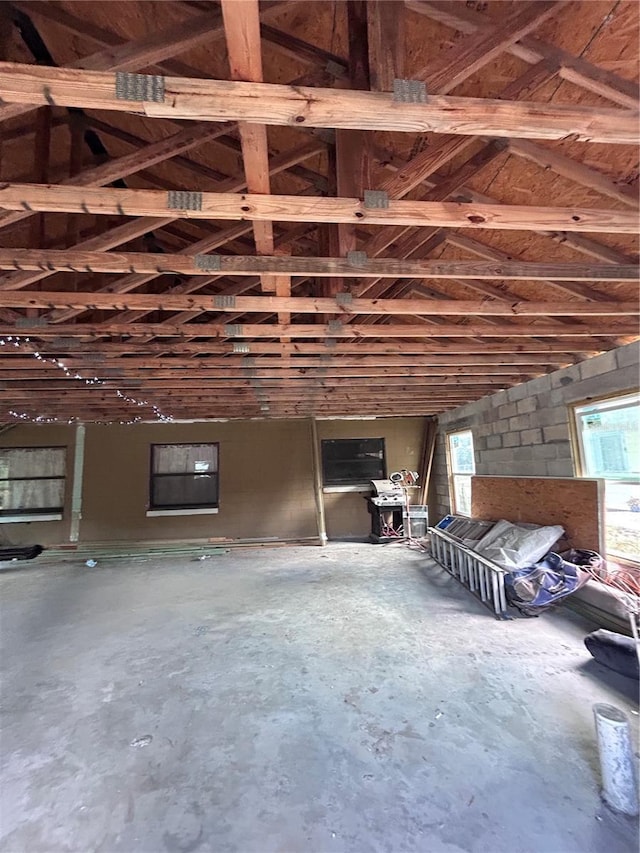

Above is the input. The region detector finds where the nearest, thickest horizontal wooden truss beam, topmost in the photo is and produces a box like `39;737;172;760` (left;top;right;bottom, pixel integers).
0;62;639;145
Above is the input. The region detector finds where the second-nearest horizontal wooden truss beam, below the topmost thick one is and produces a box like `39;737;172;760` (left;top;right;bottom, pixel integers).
0;183;638;234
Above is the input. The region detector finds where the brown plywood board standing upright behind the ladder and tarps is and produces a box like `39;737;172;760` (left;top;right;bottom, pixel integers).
471;476;604;554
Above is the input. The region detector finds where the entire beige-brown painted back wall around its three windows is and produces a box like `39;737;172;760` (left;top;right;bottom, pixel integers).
0;418;423;545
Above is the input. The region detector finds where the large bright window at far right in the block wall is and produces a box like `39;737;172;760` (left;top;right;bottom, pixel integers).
574;394;640;562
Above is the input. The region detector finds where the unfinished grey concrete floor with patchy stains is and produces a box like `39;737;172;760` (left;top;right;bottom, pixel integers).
0;544;638;853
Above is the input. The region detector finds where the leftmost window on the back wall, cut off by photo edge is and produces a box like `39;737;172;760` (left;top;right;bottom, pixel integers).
0;447;67;521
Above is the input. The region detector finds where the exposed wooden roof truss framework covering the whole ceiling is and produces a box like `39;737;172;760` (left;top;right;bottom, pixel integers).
0;0;640;423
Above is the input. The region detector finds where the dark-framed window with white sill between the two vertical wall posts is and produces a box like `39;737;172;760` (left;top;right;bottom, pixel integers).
148;444;218;515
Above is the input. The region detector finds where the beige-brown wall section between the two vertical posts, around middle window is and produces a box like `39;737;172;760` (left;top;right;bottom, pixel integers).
80;420;317;541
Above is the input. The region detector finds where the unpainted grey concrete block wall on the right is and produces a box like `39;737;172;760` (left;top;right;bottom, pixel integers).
430;342;640;520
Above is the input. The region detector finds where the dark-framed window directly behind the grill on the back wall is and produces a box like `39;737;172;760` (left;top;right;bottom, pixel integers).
322;438;386;486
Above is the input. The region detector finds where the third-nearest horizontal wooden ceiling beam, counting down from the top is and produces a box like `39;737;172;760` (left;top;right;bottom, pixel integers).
0;250;640;282
